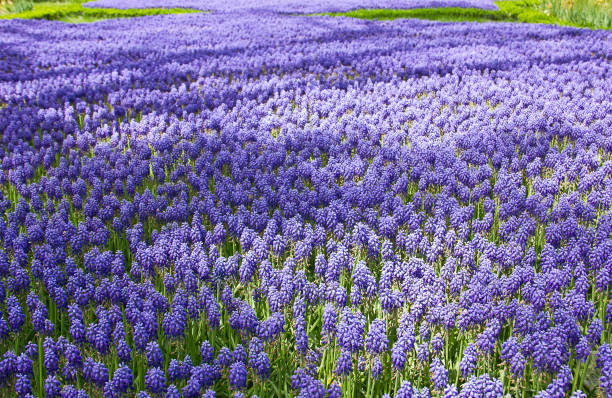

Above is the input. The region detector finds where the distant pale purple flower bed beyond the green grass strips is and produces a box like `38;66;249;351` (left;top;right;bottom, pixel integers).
83;0;498;14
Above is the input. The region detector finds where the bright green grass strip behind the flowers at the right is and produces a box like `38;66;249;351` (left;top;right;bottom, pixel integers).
325;0;612;29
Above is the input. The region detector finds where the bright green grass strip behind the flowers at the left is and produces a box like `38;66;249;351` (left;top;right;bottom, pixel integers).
0;2;200;23
